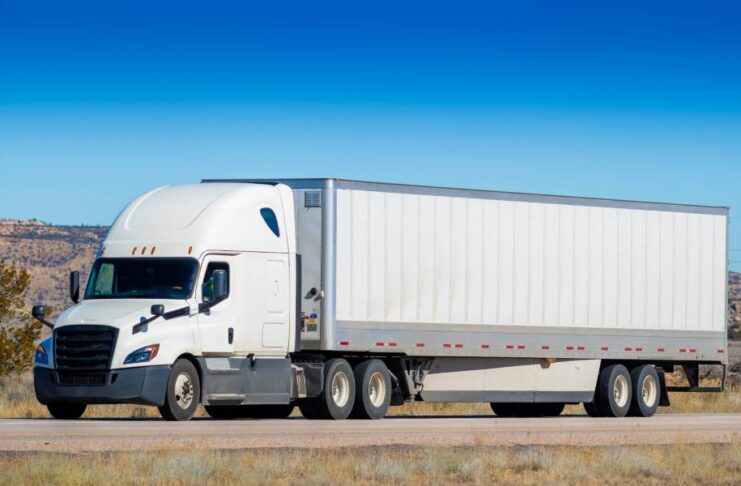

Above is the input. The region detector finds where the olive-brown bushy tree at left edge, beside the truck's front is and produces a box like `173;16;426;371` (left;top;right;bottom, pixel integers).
0;260;41;376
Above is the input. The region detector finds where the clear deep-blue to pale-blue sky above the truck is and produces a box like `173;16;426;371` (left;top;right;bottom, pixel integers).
0;0;741;270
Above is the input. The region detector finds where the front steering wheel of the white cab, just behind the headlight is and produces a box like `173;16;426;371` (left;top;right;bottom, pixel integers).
158;359;201;420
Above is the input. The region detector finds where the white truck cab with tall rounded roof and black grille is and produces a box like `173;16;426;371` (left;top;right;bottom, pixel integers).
35;184;296;418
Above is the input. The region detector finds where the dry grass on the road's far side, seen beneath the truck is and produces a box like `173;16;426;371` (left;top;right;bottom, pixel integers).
0;373;741;418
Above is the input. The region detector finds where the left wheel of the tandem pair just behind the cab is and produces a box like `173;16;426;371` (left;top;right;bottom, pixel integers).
299;358;355;420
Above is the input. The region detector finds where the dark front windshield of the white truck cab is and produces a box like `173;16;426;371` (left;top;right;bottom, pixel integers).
85;258;198;299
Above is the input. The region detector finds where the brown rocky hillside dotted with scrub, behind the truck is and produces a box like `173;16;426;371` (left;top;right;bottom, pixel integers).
0;220;741;339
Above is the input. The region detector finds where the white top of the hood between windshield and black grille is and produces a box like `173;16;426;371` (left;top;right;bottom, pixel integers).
55;299;187;329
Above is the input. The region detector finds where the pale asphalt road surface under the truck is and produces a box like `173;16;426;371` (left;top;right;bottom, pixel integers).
0;414;741;452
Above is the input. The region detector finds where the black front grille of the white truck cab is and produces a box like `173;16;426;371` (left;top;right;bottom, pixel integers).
54;325;118;371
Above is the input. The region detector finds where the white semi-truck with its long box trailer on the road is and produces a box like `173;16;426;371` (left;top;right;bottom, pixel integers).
32;178;729;420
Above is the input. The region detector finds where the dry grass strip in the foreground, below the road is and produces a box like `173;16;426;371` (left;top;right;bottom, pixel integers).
0;444;741;485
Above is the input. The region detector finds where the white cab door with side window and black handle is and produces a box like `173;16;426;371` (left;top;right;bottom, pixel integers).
196;255;237;354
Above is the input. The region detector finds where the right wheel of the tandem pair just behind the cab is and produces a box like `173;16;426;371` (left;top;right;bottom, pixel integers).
350;359;391;420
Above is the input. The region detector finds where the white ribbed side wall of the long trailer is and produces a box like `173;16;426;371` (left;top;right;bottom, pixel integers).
336;184;727;358
